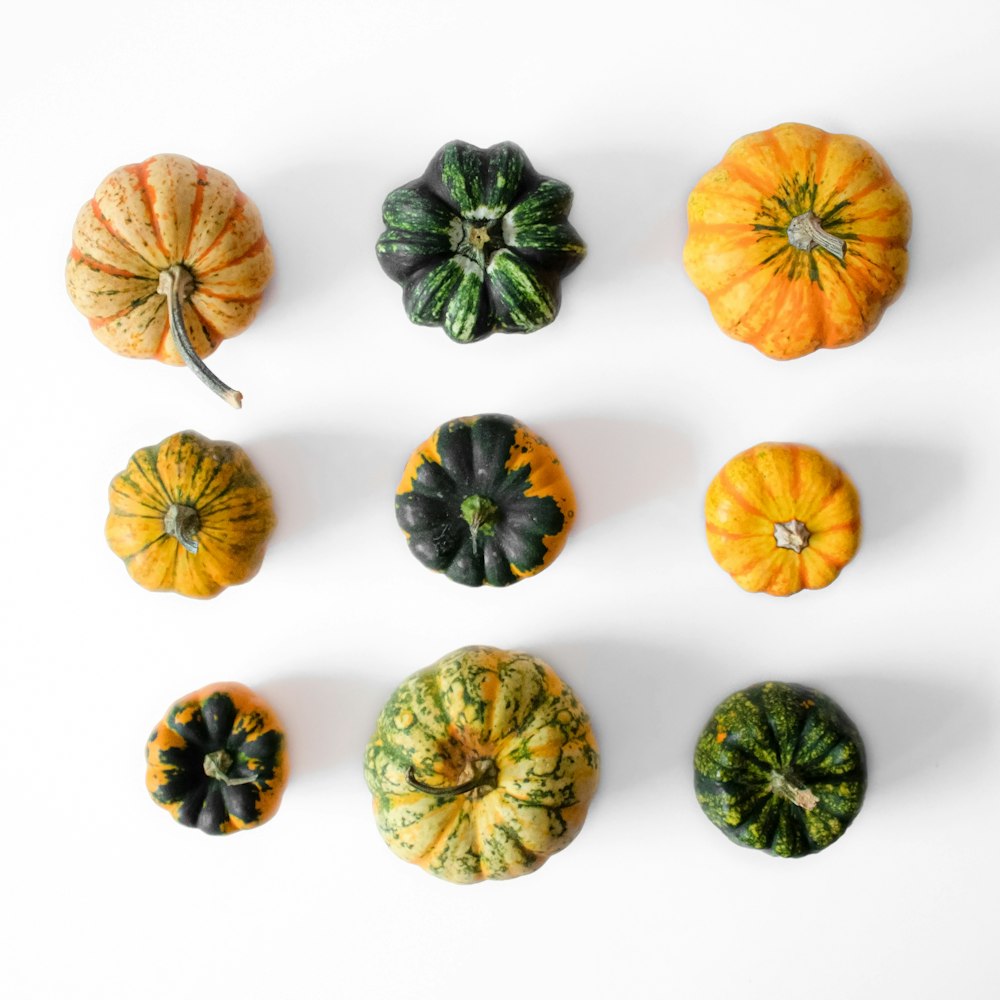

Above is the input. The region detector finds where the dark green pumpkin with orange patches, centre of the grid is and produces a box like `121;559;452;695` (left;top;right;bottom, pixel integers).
396;413;576;587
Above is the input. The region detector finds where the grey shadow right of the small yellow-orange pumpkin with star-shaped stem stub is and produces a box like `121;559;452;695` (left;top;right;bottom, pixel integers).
831;442;964;546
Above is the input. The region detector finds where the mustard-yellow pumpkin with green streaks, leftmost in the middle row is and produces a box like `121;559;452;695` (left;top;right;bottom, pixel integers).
105;431;275;597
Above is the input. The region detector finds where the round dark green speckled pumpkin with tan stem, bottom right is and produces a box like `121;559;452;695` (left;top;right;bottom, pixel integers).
694;681;867;858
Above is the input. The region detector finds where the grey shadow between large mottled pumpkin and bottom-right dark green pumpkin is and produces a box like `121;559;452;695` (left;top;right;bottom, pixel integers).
531;637;726;799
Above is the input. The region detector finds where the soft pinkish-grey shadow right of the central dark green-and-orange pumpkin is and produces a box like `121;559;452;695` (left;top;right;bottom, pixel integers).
545;416;695;530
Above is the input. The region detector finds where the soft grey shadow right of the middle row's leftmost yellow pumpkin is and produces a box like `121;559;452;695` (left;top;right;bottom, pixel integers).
247;430;394;538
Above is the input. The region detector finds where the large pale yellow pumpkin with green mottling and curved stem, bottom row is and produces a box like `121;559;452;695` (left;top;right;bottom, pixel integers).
365;646;598;883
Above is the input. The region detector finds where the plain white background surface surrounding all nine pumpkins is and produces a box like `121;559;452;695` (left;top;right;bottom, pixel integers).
0;0;1000;1000
